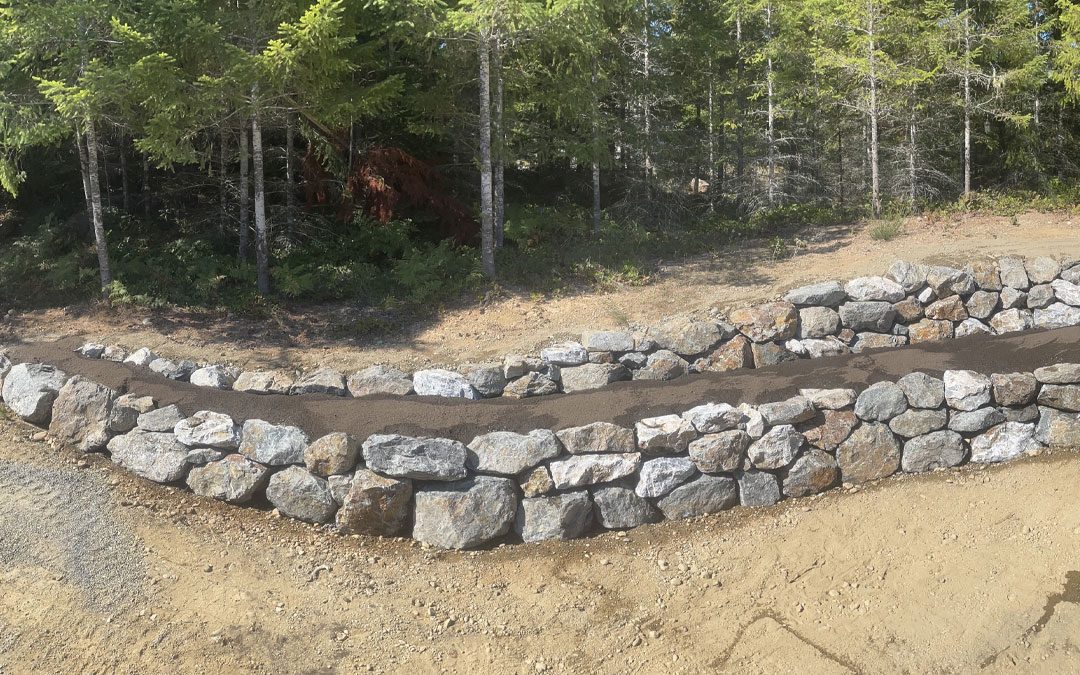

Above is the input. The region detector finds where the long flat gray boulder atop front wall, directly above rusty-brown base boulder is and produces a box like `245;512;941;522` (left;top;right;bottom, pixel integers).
363;434;468;481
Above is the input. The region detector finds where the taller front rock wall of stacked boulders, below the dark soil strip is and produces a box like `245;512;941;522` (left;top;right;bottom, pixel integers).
0;341;1080;549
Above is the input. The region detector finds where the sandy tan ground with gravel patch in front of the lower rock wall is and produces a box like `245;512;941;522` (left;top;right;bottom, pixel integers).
0;412;1080;673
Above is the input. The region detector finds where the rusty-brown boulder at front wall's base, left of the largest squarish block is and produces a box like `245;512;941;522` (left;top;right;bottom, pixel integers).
332;469;413;537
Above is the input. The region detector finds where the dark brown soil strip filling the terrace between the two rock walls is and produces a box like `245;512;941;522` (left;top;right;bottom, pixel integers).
6;327;1080;443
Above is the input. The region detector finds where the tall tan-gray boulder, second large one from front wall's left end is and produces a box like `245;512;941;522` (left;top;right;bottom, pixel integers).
49;375;117;453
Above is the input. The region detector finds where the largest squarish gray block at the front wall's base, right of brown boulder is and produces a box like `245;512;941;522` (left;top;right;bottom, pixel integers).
413;476;517;549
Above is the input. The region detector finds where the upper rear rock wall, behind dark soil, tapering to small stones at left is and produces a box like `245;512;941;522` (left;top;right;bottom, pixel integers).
71;257;1080;400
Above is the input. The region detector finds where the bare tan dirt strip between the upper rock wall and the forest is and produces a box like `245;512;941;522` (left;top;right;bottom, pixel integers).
6;213;1080;372
